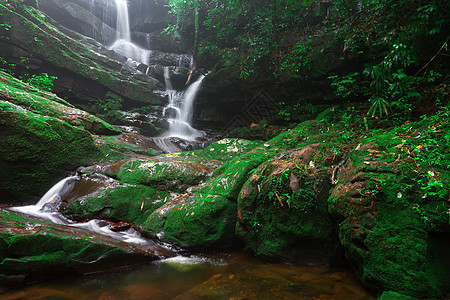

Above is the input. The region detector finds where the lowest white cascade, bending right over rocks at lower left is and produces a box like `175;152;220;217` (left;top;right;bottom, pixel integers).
9;176;149;245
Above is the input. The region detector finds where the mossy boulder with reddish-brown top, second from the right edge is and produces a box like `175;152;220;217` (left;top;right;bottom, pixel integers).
236;144;342;264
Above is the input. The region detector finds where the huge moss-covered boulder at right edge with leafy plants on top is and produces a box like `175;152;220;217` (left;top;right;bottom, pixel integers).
328;117;450;298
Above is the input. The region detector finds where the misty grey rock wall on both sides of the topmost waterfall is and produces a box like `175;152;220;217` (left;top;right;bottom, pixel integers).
39;0;176;52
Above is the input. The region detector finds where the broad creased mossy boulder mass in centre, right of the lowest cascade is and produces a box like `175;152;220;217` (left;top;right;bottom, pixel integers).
63;138;259;249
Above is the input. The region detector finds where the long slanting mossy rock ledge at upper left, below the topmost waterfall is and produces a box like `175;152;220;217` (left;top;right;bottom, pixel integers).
0;0;163;112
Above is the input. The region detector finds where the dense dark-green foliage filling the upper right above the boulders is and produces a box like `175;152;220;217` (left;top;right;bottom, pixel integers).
166;0;450;119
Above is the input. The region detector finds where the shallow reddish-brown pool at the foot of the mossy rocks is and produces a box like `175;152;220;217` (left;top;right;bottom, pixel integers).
0;253;375;300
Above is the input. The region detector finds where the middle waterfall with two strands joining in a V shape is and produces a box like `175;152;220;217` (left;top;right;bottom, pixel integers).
163;69;205;141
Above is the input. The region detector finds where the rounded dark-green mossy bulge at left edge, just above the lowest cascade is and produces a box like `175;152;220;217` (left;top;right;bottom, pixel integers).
0;101;101;200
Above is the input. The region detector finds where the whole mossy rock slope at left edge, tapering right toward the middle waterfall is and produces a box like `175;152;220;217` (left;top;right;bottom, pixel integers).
0;72;167;205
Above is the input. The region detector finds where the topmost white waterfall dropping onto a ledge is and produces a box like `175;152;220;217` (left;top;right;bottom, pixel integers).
109;0;151;65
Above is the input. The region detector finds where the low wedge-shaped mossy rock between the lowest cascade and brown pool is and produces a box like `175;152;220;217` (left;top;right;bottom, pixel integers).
0;211;173;292
